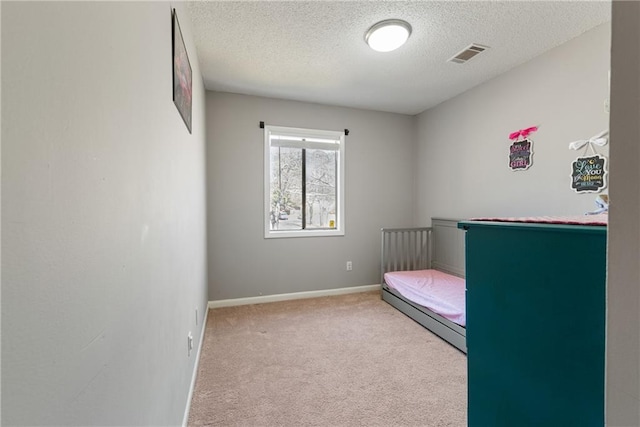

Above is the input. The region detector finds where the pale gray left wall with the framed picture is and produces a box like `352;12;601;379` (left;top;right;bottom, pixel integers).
2;2;207;425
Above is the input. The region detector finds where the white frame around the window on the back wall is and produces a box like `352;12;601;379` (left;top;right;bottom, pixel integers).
262;125;345;239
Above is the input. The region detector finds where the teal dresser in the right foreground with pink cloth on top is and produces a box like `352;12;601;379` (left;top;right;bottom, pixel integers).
458;221;607;427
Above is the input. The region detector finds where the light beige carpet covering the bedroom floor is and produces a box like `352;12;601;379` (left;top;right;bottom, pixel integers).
189;292;467;427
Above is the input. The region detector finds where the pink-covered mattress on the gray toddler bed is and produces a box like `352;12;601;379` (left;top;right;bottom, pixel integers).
384;270;466;326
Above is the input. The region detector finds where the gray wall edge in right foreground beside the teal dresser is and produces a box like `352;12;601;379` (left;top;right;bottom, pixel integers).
606;1;640;427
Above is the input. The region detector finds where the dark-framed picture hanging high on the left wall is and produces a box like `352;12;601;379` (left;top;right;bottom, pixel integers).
171;9;192;133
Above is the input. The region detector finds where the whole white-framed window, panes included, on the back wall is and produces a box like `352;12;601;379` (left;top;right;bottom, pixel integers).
264;126;344;238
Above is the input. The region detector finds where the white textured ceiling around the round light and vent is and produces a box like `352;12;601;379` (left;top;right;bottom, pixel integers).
188;1;611;114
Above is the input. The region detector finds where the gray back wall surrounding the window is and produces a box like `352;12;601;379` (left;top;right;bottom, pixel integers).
207;92;414;300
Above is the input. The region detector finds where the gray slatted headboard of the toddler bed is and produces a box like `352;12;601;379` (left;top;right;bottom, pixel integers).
380;227;432;283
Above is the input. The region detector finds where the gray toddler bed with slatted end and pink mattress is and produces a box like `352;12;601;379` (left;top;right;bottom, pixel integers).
381;218;467;353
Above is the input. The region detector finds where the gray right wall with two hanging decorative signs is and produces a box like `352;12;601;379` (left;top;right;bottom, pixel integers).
415;23;610;223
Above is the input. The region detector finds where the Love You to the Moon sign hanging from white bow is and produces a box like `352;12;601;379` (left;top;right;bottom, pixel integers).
569;130;609;193
